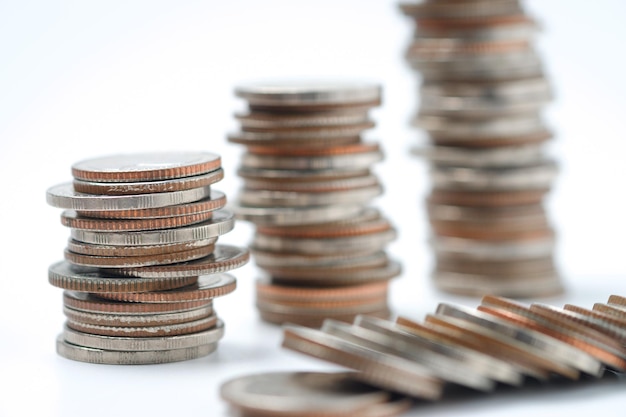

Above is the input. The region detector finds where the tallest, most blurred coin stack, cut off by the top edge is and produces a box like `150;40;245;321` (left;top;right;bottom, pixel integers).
401;0;563;297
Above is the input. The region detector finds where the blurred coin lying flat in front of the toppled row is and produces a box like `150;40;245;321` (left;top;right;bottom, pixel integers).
220;372;391;417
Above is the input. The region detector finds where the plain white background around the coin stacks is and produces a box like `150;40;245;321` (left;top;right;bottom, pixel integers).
0;0;626;417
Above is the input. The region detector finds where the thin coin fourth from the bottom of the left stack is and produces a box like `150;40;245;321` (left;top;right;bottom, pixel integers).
63;306;215;327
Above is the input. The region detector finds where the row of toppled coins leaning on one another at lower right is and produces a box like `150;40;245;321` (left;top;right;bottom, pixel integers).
283;295;626;400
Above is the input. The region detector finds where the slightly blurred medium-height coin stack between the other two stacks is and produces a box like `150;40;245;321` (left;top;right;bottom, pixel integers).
228;82;400;327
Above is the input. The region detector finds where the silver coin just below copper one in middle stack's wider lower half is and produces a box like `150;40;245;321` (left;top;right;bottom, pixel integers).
251;229;397;255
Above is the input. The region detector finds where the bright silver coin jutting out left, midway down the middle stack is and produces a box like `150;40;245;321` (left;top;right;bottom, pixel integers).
233;204;363;226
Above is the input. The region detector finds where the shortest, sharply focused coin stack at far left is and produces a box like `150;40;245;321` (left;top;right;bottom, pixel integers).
46;152;249;364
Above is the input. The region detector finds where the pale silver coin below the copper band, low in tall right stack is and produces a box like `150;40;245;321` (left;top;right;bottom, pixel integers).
430;236;555;260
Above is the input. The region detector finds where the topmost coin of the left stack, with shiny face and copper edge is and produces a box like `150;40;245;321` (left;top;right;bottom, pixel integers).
72;151;221;182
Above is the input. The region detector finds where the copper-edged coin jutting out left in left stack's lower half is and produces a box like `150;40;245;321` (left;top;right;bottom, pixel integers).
48;261;198;293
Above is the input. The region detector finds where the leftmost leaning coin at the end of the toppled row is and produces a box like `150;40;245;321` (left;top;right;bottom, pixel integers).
282;325;443;400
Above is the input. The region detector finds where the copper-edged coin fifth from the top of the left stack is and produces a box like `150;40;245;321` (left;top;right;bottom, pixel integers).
61;210;213;232
